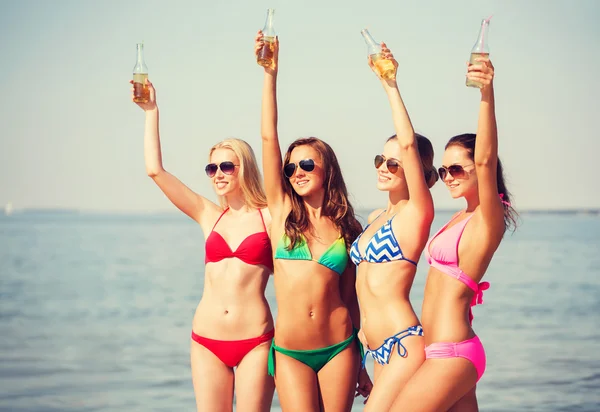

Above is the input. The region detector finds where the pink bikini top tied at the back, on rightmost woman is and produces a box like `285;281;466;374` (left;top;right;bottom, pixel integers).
425;213;490;323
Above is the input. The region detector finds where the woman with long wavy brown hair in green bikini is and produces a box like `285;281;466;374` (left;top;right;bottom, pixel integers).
255;32;371;411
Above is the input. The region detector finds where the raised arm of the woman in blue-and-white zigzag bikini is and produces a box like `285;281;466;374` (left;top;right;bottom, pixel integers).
369;43;433;218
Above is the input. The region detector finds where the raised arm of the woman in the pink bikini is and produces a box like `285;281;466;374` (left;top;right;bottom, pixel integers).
467;58;504;228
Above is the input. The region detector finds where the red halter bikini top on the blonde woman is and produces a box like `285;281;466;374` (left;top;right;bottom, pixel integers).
204;208;273;271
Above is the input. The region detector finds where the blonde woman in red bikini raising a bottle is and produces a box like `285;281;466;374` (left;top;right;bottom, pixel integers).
132;81;275;412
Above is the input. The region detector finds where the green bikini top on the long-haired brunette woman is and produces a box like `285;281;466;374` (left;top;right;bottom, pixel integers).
274;233;348;275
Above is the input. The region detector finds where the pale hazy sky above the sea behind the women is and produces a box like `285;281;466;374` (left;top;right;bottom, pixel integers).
0;0;600;213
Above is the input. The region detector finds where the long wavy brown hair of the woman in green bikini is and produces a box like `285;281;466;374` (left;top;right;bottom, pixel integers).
282;137;362;250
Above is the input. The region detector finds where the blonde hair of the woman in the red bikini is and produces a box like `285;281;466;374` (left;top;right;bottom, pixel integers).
208;138;267;209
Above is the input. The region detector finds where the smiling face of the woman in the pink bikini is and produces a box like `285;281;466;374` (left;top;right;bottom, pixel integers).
442;145;477;199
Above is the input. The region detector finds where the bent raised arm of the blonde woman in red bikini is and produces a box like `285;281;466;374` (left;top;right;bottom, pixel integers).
130;80;220;224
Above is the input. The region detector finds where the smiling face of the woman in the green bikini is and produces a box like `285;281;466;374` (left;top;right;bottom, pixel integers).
287;145;324;197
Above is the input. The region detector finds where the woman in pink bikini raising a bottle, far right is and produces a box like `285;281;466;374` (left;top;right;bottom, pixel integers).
391;58;516;412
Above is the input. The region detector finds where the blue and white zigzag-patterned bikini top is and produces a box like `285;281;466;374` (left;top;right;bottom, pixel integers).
350;212;417;266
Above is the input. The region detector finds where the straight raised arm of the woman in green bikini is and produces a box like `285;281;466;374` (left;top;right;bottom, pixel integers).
254;31;285;217
